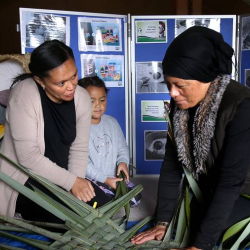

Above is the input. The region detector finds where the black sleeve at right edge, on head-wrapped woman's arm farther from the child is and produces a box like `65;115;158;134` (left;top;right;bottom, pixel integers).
194;99;250;250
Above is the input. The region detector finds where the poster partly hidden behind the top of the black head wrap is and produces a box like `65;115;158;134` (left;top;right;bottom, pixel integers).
175;18;220;37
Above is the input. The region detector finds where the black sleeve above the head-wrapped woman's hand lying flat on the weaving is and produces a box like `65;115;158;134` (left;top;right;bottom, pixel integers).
155;136;183;222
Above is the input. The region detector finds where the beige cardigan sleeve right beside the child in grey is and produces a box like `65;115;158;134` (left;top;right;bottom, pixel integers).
68;89;92;178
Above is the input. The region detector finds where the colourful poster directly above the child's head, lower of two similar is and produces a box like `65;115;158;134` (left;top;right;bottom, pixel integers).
81;54;124;87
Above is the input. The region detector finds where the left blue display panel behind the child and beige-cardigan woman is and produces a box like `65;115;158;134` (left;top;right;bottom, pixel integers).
20;8;128;138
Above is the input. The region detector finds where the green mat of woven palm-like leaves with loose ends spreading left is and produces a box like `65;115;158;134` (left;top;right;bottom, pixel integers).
0;153;173;250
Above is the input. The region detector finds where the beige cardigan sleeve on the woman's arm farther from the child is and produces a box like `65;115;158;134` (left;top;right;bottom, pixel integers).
7;92;76;190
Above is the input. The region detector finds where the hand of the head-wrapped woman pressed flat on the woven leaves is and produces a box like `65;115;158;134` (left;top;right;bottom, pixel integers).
131;225;167;245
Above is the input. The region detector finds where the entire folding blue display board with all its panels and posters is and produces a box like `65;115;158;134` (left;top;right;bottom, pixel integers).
20;8;238;175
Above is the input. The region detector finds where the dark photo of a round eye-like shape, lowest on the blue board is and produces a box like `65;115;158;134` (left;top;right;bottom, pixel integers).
144;130;167;161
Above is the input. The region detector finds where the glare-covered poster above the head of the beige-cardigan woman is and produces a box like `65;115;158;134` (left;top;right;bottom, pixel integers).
22;12;70;48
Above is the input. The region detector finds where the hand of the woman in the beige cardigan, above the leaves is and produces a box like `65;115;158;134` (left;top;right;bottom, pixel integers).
70;177;95;202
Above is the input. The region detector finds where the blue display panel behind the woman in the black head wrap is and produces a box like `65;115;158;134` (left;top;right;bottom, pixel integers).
131;15;236;175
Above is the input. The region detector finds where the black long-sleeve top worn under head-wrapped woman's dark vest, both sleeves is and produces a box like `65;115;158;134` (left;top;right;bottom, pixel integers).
156;99;250;250
